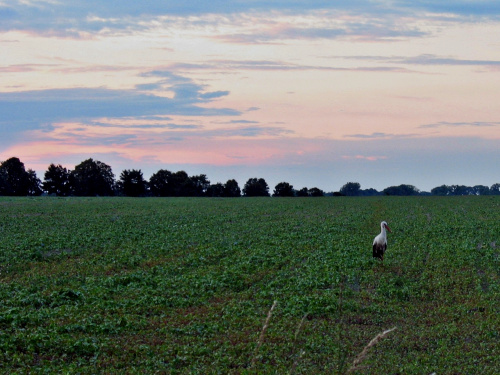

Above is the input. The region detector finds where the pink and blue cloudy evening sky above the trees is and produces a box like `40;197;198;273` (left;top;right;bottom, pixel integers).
0;0;500;193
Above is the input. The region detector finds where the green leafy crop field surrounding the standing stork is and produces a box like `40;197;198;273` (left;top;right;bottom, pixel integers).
0;196;500;375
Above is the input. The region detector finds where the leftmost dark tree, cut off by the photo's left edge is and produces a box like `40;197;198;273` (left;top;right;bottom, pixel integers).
0;157;42;196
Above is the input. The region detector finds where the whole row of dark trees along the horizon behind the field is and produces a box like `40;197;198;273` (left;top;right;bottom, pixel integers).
0;157;500;197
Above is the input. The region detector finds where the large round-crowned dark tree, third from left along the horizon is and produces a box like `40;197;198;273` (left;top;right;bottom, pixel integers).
71;159;115;196
